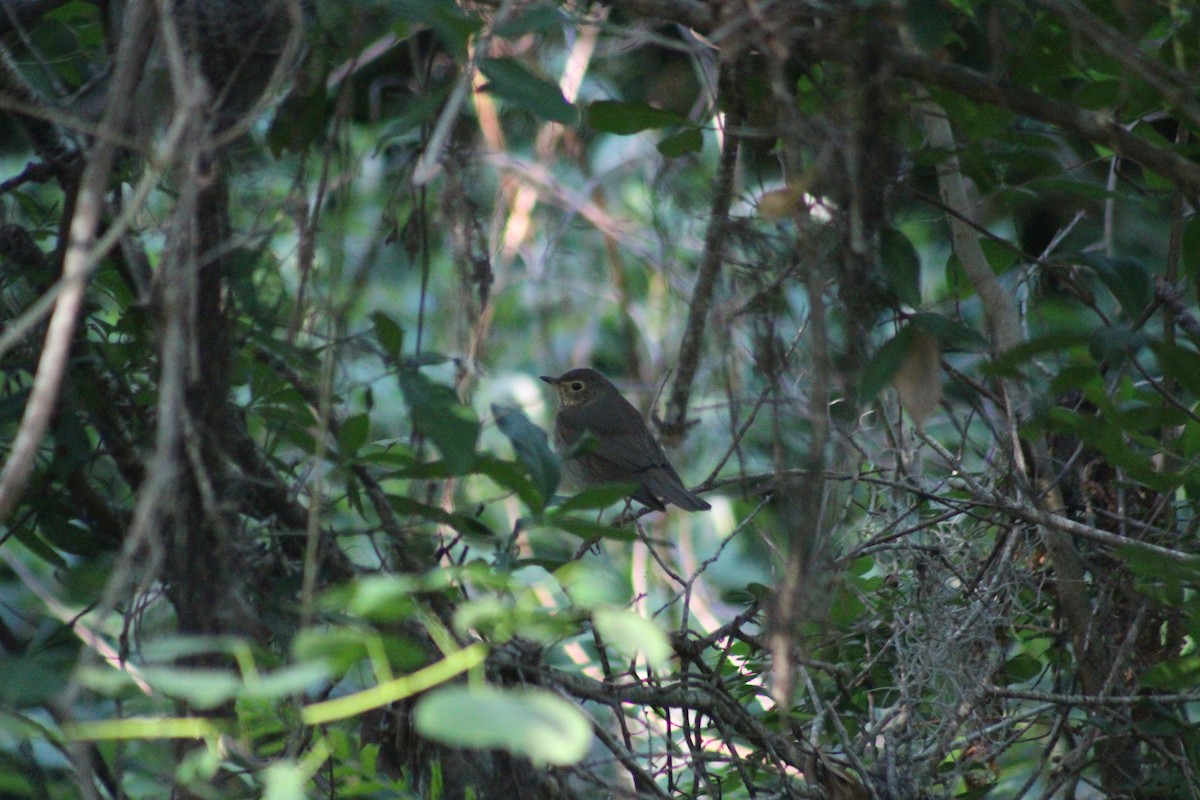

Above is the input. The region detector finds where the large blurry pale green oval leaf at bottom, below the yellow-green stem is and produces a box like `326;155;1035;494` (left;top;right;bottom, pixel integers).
413;686;592;765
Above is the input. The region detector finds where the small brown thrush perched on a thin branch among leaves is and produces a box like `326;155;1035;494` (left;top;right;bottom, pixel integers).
541;368;712;511
